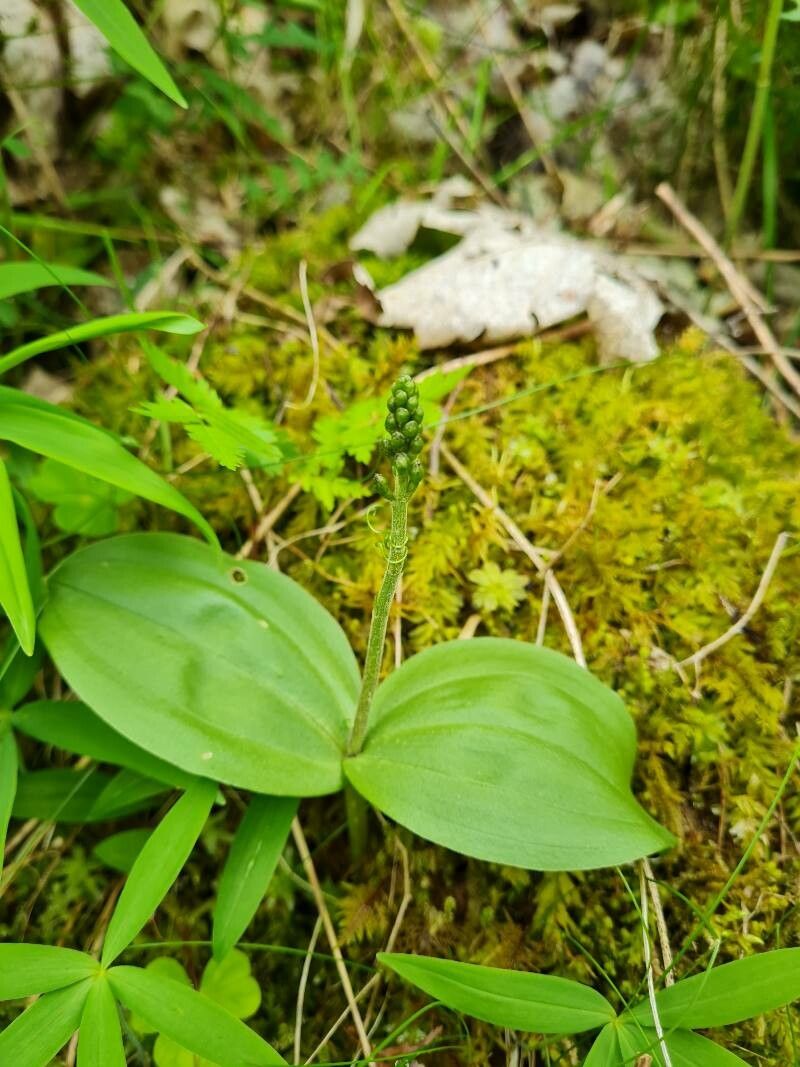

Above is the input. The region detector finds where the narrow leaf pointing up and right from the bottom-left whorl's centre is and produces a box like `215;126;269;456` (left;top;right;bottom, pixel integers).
102;779;217;967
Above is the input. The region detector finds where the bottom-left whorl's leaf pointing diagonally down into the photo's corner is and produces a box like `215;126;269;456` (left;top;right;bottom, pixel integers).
0;978;93;1067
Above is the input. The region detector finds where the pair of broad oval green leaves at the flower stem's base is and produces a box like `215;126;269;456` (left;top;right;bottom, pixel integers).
41;534;671;870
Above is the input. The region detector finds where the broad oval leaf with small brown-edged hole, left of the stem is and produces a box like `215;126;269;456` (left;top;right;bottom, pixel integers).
42;534;358;796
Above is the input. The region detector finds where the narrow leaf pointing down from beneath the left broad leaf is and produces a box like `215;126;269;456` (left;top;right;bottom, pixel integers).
213;796;298;959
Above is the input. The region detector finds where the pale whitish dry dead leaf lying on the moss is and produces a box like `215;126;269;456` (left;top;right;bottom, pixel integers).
350;178;665;363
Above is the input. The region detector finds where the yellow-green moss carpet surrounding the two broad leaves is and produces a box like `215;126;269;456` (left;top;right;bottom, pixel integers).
0;214;800;1065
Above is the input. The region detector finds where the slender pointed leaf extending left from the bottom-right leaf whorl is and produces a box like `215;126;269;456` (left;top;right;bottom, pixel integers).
378;952;614;1034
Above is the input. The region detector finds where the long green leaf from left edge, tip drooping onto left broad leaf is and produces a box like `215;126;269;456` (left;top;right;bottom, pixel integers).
0;385;217;543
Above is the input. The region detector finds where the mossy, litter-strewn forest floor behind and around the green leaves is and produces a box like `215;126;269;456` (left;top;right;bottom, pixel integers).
0;0;800;1067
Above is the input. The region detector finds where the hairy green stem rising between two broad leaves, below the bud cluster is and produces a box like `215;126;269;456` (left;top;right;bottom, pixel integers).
348;488;409;755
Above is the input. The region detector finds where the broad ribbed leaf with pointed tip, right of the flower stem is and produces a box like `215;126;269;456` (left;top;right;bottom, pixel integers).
345;637;673;871
